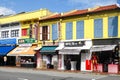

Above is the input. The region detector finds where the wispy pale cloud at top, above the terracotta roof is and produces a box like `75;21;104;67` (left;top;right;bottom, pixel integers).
68;0;117;9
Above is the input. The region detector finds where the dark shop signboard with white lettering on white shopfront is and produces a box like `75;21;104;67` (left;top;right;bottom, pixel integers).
64;41;85;47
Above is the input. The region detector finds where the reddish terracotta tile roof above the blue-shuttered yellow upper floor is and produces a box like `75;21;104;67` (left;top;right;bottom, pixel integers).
40;4;120;20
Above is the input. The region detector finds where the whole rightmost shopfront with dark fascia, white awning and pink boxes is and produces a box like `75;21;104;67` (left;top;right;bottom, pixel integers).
90;39;119;73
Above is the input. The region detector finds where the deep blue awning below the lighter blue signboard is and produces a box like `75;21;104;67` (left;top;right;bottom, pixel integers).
0;46;15;56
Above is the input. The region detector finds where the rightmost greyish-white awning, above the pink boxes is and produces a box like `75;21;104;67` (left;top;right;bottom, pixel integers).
90;45;116;52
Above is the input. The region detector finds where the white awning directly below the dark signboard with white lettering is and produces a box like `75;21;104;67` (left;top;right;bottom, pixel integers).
59;47;81;55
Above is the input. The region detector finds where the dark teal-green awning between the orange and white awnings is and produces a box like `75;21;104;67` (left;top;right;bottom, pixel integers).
40;46;57;54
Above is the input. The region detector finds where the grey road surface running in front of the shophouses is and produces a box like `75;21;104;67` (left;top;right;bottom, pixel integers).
0;67;120;80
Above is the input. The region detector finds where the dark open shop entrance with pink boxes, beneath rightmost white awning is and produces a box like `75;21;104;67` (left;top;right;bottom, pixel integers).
91;50;119;73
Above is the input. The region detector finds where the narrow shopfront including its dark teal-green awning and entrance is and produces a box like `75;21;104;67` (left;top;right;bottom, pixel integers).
40;46;58;69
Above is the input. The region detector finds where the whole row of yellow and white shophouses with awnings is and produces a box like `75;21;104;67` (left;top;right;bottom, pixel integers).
0;5;120;73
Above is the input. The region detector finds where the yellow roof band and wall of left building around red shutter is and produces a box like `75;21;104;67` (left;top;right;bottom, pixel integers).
0;9;52;38
